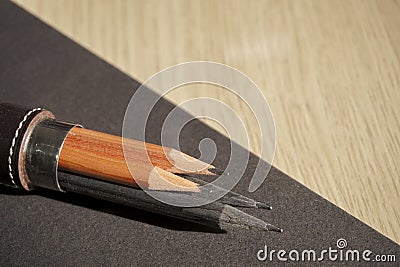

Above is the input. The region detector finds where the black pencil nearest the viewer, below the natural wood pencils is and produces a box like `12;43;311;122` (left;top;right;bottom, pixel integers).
59;174;282;232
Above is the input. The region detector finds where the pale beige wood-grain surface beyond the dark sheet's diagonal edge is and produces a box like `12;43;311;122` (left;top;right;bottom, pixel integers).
14;0;400;242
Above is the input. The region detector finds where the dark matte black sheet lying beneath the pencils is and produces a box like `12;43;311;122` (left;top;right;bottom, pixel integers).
0;1;400;266
